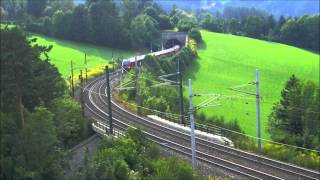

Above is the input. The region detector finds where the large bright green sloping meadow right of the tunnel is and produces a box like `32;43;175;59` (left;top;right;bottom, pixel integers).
184;31;319;138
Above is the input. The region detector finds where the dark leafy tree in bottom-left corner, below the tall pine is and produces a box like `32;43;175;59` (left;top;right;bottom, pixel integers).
1;106;63;179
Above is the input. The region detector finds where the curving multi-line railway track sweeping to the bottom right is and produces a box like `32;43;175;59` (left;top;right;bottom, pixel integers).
85;75;320;179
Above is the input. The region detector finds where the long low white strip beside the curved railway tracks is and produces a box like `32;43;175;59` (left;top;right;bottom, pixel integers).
148;115;234;147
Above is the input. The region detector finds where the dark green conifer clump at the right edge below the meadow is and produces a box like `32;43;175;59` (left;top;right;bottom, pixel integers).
269;75;320;150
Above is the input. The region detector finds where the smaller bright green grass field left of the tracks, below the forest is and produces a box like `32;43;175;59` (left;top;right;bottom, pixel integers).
32;35;134;78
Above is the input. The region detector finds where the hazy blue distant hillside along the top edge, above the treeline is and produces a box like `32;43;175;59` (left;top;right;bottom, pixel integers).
155;0;319;17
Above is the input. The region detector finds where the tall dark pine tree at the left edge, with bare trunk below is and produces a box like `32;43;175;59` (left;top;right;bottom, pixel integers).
0;28;66;129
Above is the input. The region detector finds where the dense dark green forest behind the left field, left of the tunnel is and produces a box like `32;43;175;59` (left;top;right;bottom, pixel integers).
1;0;173;49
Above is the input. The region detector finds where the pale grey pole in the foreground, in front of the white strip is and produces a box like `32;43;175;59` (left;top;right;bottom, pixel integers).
189;79;196;169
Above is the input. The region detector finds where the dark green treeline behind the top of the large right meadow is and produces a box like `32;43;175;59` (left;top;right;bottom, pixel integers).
197;7;320;52
